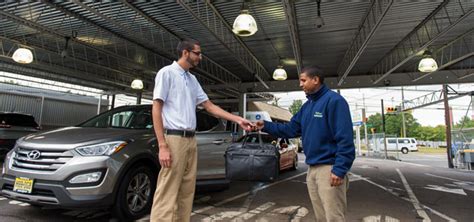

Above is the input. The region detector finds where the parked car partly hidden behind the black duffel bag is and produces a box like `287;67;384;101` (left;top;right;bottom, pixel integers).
237;132;298;171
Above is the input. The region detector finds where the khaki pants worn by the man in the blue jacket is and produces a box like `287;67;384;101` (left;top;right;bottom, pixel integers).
306;165;349;222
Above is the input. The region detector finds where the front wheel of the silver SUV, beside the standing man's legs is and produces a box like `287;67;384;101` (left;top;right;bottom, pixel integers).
113;165;157;221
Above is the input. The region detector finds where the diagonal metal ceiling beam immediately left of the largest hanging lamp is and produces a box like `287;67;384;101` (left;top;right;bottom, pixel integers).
177;0;270;83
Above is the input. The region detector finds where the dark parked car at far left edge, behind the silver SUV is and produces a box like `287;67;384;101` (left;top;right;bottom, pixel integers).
0;112;39;158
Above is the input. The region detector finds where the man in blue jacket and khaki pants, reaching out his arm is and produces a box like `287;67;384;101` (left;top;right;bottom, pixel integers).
256;66;355;221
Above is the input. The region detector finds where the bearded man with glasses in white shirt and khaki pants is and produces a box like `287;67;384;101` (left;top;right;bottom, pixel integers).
150;39;254;222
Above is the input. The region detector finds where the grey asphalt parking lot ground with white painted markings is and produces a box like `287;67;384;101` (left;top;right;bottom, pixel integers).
0;153;474;222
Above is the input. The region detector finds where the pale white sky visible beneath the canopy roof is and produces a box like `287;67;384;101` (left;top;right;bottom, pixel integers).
274;83;474;126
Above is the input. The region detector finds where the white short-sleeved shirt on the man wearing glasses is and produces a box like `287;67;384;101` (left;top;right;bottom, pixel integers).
153;61;209;130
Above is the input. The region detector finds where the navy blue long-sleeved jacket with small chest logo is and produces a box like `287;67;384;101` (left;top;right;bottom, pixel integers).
263;84;355;178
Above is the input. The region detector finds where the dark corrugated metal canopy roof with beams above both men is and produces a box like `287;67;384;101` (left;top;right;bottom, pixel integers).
0;0;474;99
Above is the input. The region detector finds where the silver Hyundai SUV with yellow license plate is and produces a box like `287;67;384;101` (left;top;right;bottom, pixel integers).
0;105;232;220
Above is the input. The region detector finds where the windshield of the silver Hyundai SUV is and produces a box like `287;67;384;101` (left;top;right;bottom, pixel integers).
79;106;153;129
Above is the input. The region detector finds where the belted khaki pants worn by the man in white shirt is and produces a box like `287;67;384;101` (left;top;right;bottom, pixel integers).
150;135;197;222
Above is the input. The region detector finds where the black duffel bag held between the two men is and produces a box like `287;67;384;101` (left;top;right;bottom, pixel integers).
224;133;280;182
